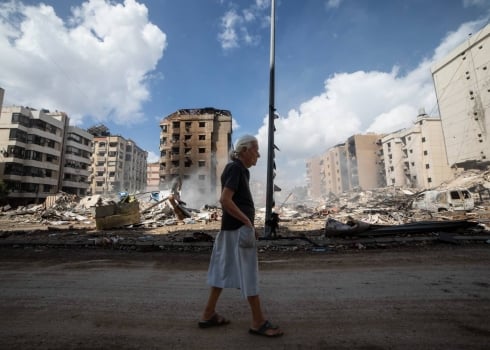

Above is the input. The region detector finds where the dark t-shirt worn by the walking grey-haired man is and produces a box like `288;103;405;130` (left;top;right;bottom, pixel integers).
221;160;255;230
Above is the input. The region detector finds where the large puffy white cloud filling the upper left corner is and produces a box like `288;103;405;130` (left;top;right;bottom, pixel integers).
0;0;167;123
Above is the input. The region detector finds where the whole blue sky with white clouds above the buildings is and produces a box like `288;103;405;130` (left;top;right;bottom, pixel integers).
0;0;490;194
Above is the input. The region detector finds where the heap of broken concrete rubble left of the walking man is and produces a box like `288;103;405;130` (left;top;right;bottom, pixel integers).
0;191;221;229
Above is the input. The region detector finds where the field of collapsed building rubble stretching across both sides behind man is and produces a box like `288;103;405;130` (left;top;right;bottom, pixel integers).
0;172;490;252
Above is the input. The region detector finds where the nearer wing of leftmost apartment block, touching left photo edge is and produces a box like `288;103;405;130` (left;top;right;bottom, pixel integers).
0;106;68;206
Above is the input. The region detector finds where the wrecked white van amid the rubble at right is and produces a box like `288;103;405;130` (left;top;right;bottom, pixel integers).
412;188;475;212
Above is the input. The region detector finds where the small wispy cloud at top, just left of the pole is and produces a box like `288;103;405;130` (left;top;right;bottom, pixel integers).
218;0;270;50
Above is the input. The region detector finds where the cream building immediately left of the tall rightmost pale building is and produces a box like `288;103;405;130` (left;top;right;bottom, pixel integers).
381;111;453;189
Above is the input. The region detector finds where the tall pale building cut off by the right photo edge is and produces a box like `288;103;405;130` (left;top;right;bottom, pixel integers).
432;24;490;168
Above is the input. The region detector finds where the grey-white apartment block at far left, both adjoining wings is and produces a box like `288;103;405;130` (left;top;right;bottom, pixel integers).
0;91;92;206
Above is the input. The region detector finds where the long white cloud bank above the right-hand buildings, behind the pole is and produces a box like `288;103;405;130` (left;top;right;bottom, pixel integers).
252;20;486;194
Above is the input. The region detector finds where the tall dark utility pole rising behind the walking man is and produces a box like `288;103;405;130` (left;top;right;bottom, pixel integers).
264;0;276;238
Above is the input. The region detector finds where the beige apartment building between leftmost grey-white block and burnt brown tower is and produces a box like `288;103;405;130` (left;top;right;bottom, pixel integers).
89;125;148;195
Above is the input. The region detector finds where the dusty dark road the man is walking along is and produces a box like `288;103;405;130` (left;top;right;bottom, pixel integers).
0;245;490;350
